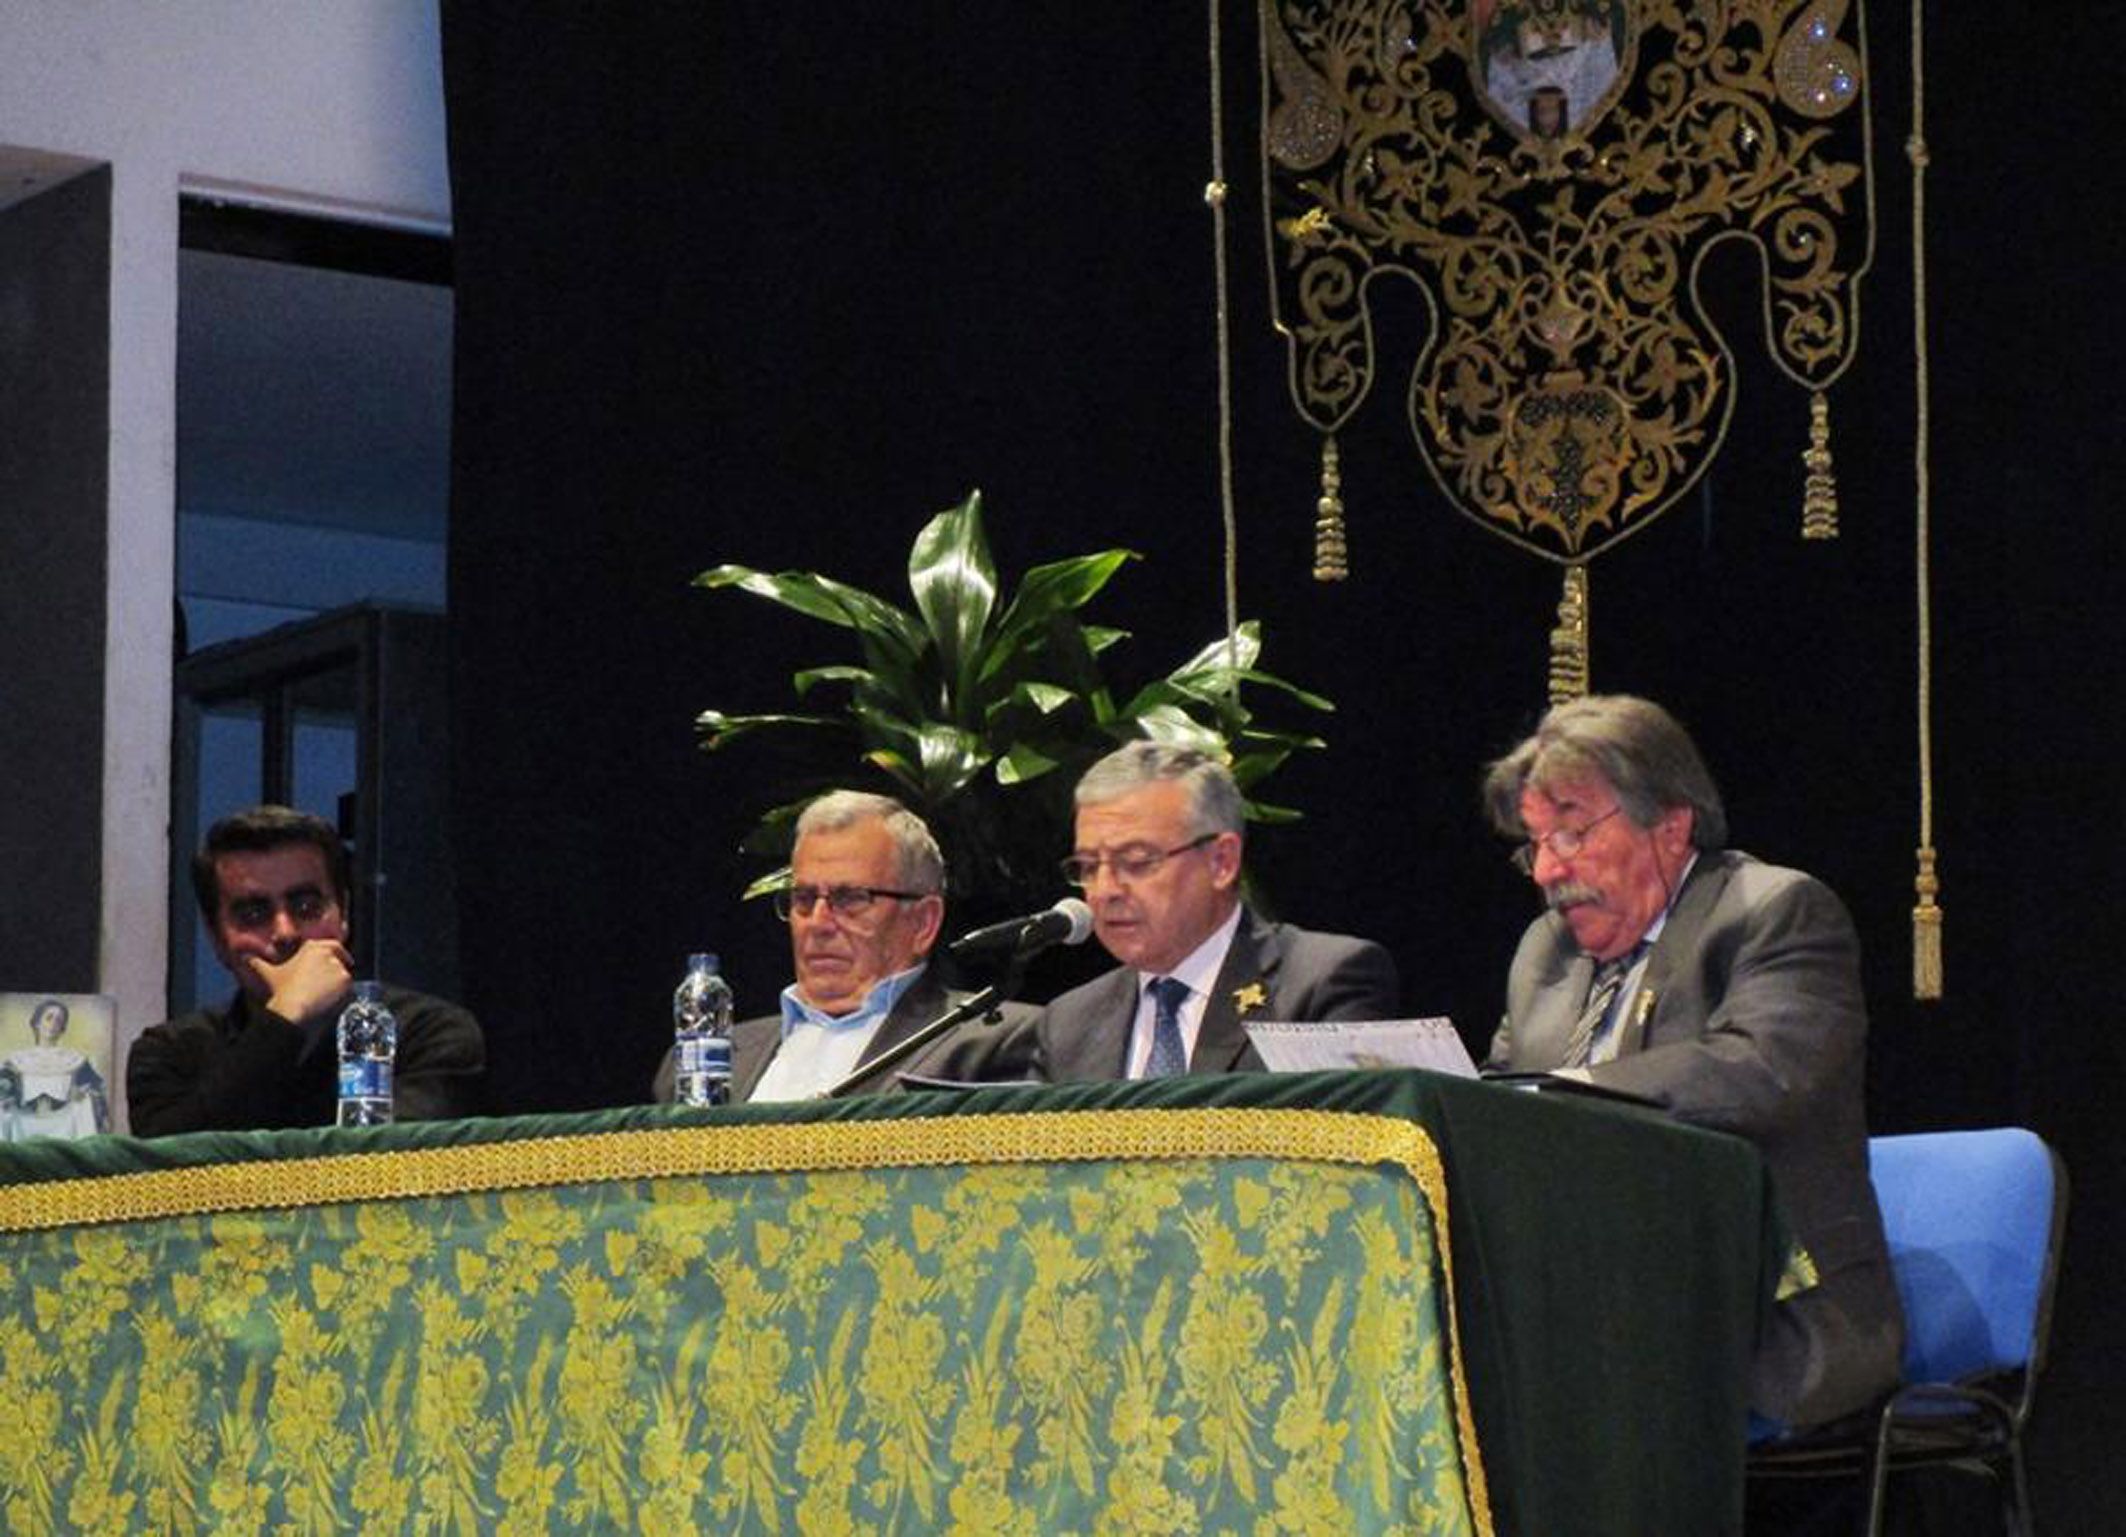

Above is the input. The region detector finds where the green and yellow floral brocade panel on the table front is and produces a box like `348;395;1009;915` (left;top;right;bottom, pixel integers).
0;1127;1490;1537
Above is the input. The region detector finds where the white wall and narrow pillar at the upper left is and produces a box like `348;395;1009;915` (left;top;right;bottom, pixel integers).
0;0;451;1071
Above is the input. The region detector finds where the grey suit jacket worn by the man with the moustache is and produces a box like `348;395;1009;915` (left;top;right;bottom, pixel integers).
1484;850;1903;1424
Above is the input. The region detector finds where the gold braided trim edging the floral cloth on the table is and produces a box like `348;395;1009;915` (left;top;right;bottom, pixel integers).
0;1108;1492;1537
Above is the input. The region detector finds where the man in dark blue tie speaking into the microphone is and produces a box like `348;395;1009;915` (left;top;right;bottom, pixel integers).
1035;742;1401;1082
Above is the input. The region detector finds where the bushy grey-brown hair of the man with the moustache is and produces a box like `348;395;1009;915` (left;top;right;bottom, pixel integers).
1484;693;1726;848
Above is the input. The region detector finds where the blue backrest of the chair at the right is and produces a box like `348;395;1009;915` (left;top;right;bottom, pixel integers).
1869;1127;2066;1382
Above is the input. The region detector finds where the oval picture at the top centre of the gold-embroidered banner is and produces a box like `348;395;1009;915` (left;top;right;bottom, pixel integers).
1469;0;1626;138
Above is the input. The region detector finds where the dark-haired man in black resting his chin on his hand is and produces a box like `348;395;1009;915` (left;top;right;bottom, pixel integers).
125;806;487;1137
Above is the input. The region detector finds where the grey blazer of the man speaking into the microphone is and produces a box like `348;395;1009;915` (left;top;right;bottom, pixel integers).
1033;910;1401;1082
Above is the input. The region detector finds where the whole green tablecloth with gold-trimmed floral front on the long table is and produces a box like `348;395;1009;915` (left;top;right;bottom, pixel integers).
0;1074;1777;1537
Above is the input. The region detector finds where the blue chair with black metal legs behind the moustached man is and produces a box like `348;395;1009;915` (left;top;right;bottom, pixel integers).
1750;1127;2066;1537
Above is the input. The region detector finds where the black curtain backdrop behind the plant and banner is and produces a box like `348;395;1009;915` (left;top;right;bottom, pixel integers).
444;0;2126;1531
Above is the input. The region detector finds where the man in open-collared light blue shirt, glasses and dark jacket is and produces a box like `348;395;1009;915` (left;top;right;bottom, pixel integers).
653;791;1033;1101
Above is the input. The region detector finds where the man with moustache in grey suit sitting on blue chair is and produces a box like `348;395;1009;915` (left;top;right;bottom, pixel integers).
1484;695;1903;1424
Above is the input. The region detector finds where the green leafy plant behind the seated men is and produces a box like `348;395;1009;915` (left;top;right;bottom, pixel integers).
695;491;1333;914
